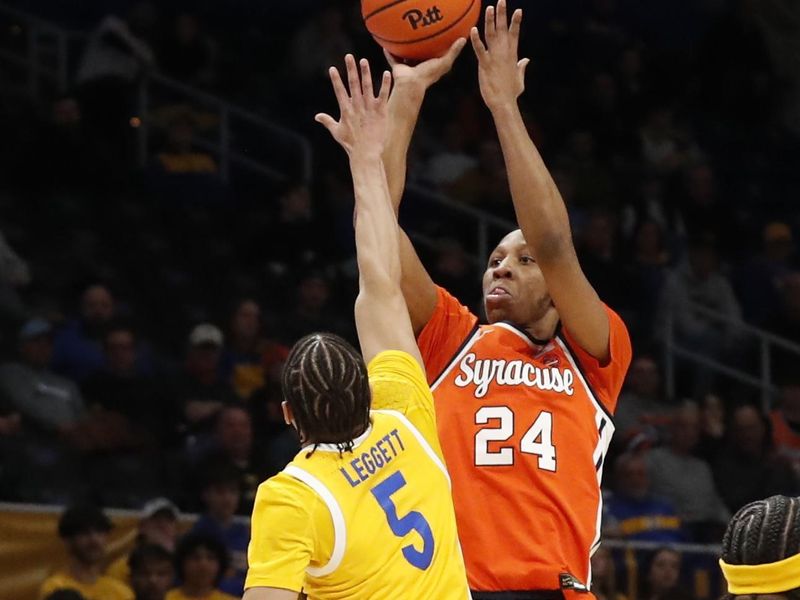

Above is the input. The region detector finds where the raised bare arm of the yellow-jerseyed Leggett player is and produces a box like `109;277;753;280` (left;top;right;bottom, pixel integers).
316;54;422;364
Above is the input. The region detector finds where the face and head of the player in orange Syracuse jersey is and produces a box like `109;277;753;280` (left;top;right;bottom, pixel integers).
483;229;553;327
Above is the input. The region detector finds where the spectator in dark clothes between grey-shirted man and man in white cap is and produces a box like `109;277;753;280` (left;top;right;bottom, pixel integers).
81;323;177;448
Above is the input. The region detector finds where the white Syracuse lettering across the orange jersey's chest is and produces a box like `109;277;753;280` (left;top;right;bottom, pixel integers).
454;352;575;398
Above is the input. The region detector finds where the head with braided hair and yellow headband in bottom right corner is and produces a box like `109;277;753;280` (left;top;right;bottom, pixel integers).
720;496;800;600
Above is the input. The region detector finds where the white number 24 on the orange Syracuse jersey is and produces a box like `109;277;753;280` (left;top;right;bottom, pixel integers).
475;406;557;472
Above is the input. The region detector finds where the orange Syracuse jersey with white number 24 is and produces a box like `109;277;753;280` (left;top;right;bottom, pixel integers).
418;288;631;591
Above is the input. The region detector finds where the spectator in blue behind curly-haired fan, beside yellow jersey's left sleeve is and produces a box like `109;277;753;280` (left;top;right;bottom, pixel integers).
191;463;250;597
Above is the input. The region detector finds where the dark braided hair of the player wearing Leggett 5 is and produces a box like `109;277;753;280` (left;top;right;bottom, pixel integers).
281;333;370;456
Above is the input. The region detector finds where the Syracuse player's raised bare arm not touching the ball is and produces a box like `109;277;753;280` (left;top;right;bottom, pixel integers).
470;0;609;362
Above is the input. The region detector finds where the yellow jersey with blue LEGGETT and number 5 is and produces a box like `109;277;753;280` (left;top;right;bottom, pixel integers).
245;351;470;600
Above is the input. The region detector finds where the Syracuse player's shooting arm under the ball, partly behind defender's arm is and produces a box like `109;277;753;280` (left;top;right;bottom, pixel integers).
383;39;466;334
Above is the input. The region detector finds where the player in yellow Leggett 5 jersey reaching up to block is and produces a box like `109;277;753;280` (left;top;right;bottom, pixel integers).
244;55;470;600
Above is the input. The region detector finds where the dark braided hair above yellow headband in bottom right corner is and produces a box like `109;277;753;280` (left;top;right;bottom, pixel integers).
722;496;800;600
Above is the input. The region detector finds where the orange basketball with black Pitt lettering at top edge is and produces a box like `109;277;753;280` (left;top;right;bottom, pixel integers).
361;0;481;61
